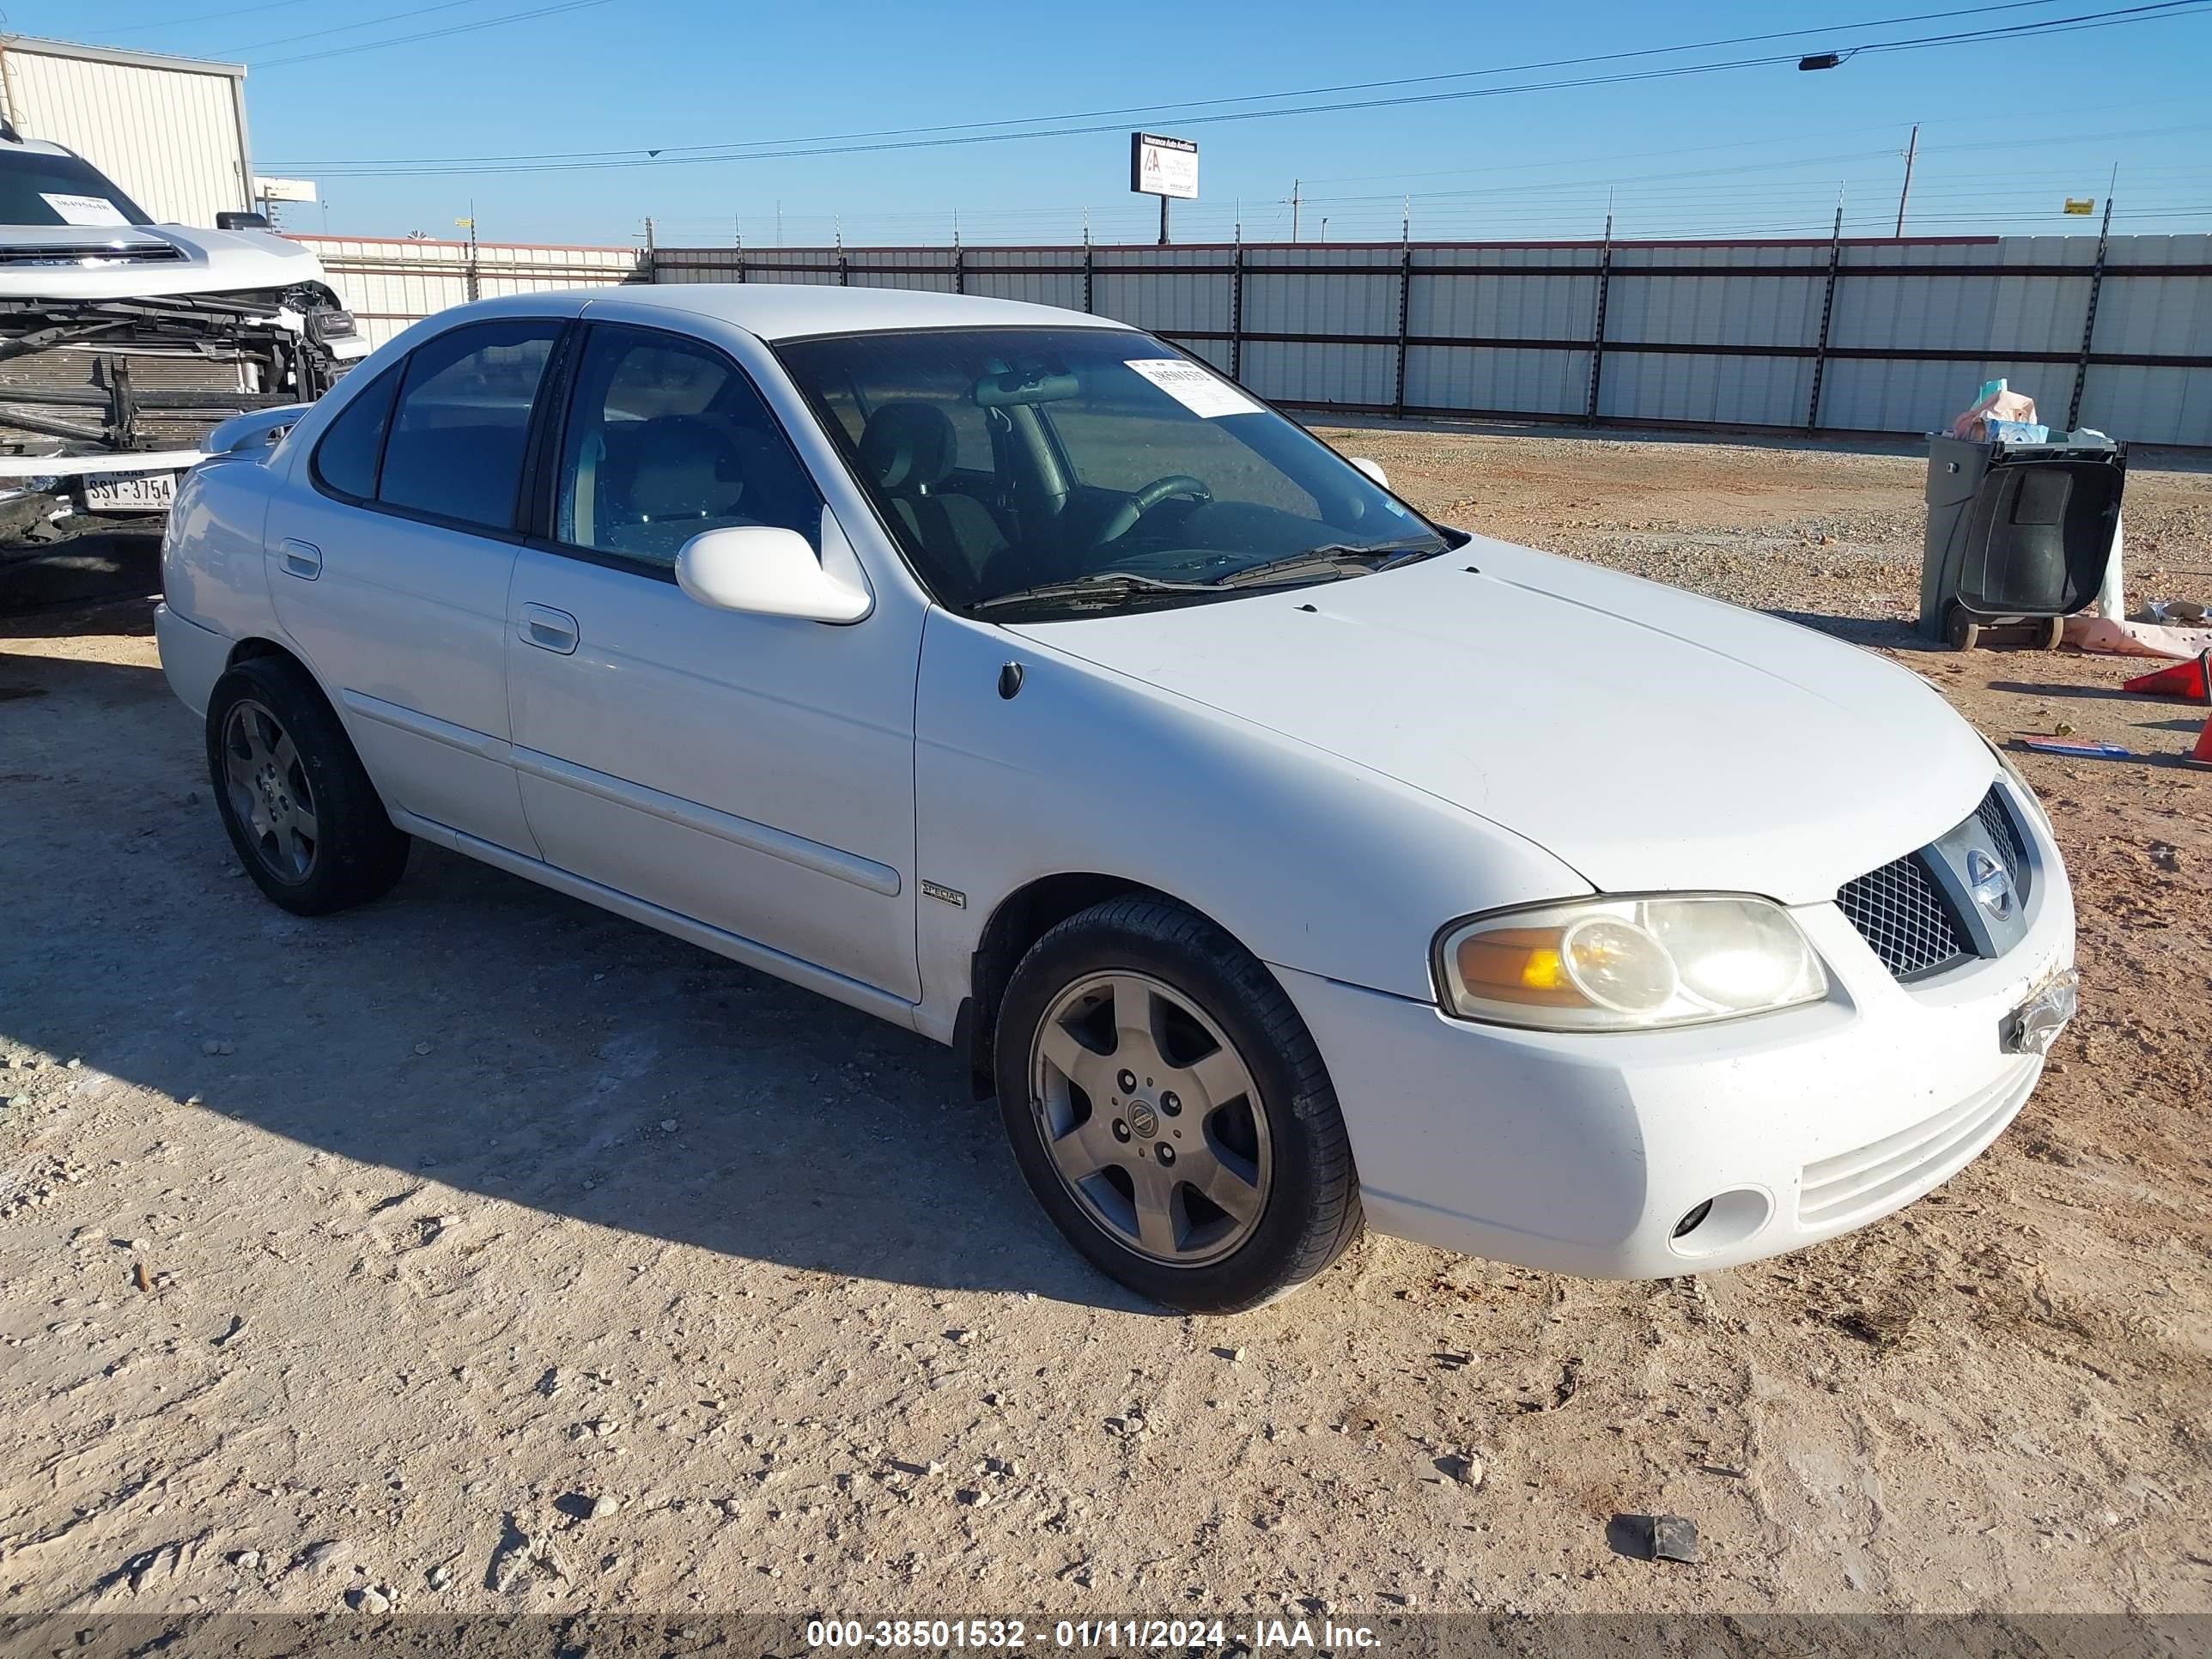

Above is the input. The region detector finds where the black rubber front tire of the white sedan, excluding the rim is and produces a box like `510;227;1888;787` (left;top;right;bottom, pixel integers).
994;894;1363;1314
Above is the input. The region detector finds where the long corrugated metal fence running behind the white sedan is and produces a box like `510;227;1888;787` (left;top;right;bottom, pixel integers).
305;237;2212;447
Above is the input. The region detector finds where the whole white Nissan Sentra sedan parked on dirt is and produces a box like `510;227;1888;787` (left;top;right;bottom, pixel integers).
159;285;2075;1312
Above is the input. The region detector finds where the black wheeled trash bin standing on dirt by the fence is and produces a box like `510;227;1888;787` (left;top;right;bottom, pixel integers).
1920;434;2128;650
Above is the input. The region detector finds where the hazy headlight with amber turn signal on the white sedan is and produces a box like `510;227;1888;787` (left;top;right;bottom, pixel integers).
1436;896;1827;1030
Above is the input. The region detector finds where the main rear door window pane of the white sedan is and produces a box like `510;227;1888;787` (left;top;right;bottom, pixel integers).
376;319;562;531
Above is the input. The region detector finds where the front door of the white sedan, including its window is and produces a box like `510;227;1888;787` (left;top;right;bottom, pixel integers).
507;325;921;1002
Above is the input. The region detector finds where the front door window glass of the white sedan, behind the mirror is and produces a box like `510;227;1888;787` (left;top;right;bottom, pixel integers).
553;325;823;568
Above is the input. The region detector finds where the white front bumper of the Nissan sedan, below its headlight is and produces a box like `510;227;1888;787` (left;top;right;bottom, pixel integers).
1276;785;2075;1279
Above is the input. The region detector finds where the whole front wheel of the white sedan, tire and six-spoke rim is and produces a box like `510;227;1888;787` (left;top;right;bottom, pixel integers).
995;896;1360;1314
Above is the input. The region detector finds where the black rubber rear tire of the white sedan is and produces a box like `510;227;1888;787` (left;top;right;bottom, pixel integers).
208;657;411;915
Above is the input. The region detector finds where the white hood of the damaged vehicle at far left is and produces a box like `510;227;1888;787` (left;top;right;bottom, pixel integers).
0;226;323;301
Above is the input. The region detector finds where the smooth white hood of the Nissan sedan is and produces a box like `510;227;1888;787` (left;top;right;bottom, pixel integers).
1011;538;1997;905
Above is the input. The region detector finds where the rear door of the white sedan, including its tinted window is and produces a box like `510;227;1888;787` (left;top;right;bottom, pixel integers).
265;316;568;856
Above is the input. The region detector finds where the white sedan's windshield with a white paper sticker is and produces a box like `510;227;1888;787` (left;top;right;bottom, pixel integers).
779;327;1449;617
